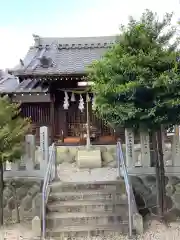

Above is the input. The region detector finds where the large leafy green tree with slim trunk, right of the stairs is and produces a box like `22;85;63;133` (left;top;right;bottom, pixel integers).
88;10;180;218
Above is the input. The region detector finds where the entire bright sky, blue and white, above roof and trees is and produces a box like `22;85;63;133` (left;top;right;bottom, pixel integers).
0;0;180;69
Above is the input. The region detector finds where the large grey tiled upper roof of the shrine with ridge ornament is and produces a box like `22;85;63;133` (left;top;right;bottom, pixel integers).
12;36;116;75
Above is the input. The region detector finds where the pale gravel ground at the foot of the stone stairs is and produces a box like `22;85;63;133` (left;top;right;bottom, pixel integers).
0;220;180;240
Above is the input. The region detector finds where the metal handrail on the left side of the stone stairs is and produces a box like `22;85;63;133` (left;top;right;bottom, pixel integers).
42;143;56;239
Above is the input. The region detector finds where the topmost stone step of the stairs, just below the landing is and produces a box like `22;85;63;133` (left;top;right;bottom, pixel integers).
50;179;125;192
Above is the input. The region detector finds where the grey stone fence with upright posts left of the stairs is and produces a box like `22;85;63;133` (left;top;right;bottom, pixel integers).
4;126;49;180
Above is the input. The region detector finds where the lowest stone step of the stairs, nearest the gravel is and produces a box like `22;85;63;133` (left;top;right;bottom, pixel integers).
47;222;131;240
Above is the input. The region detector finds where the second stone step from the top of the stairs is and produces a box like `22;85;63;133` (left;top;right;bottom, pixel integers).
48;189;127;203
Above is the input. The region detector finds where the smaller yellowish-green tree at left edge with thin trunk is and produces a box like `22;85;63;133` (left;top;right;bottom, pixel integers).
0;96;30;225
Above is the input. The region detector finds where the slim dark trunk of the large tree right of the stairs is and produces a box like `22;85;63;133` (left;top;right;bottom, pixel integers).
152;132;162;218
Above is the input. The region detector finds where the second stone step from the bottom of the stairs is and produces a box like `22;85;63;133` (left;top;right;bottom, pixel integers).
46;212;128;229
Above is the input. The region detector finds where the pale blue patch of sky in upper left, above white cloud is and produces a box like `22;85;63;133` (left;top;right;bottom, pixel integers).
0;0;86;26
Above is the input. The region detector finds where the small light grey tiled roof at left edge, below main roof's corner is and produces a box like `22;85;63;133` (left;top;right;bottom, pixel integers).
0;71;19;93
